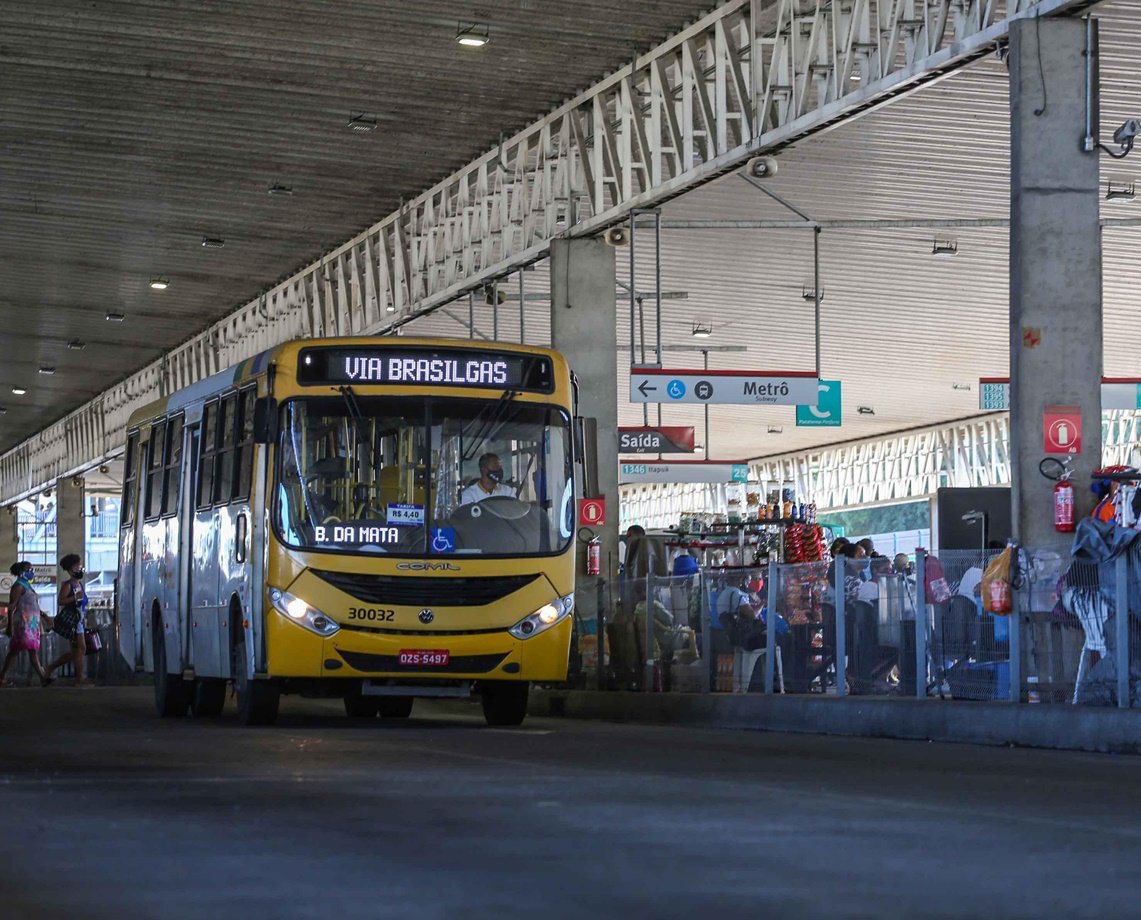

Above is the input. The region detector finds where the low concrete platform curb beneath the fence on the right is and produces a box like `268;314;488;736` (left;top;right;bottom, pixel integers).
529;688;1141;753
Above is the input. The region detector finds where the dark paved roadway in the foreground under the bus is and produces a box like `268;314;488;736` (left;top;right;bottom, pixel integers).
0;686;1141;920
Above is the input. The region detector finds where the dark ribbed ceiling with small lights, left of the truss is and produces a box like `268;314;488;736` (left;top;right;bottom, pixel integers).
0;0;712;450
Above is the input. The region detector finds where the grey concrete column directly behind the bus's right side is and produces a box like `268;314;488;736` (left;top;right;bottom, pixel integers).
551;239;618;579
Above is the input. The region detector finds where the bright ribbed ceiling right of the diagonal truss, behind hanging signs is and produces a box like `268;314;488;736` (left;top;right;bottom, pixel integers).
401;0;1141;467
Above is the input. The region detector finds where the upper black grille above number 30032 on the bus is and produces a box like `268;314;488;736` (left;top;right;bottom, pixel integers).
313;570;539;607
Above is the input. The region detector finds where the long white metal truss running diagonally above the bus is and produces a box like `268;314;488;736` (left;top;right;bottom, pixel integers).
0;0;1091;501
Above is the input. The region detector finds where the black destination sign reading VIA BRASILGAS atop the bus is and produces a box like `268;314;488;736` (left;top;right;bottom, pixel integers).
297;346;555;393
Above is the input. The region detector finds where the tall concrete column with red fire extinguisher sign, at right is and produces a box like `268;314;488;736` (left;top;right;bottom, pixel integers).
1010;18;1102;547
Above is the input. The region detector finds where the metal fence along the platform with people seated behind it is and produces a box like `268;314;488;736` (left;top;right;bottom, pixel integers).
577;540;1141;707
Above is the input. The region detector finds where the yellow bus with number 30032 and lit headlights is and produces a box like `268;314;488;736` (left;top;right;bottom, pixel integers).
118;337;576;725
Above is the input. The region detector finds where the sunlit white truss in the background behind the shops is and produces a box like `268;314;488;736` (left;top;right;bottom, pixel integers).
620;411;1141;527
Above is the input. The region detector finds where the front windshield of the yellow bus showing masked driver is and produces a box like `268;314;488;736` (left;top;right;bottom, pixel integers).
274;387;574;558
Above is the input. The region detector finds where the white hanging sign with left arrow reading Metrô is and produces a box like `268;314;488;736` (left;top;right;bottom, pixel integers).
630;368;819;405
